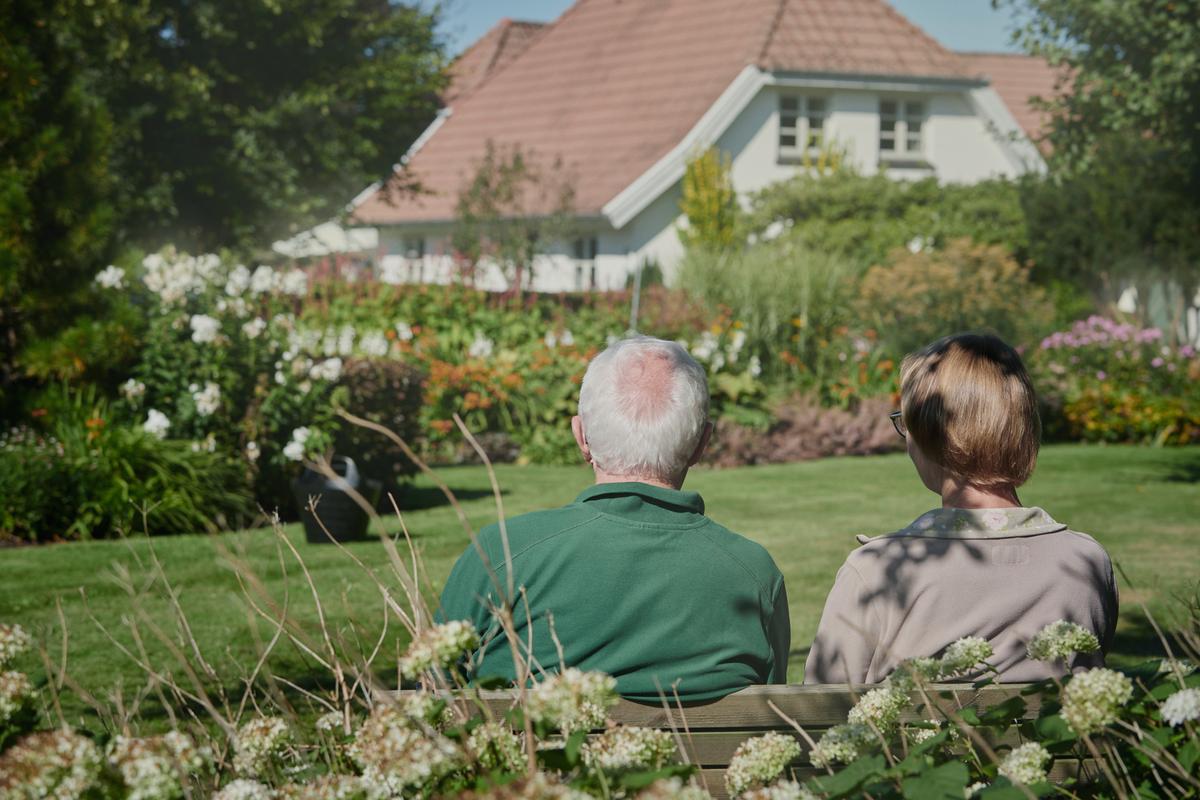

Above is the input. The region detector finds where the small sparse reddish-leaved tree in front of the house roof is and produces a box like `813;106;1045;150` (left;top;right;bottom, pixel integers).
451;140;575;293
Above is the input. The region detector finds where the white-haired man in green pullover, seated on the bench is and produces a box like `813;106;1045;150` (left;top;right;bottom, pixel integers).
440;336;791;702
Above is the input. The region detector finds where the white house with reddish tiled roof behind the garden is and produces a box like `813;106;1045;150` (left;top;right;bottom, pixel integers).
350;0;1054;291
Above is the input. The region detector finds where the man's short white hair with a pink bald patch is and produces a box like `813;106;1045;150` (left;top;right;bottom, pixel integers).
580;336;708;480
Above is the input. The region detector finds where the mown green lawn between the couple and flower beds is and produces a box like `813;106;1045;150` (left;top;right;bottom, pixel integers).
0;446;1200;724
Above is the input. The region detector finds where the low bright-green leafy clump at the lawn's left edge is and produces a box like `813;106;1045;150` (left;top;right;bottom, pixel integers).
0;383;252;542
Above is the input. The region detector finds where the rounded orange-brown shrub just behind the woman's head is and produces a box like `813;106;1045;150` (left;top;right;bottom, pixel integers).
856;239;1055;354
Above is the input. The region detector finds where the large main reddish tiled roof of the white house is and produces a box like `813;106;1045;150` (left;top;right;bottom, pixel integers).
354;0;971;224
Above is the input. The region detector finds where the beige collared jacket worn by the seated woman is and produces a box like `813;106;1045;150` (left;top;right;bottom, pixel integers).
804;509;1117;684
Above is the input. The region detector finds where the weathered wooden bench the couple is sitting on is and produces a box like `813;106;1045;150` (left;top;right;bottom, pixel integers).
446;684;1094;798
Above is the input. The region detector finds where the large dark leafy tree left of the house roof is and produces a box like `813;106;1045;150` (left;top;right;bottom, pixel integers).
94;0;445;251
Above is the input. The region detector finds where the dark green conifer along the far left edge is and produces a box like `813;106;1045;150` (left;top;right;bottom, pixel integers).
0;0;114;397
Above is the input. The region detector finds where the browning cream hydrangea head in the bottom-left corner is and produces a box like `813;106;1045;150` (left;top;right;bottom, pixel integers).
0;728;102;800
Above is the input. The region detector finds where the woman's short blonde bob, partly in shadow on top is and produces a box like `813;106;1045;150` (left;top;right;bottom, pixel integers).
900;333;1042;487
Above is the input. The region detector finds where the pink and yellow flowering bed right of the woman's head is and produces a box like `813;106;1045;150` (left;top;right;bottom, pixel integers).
1027;317;1200;444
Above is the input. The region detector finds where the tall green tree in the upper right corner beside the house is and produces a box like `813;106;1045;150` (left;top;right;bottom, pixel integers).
996;0;1200;328
